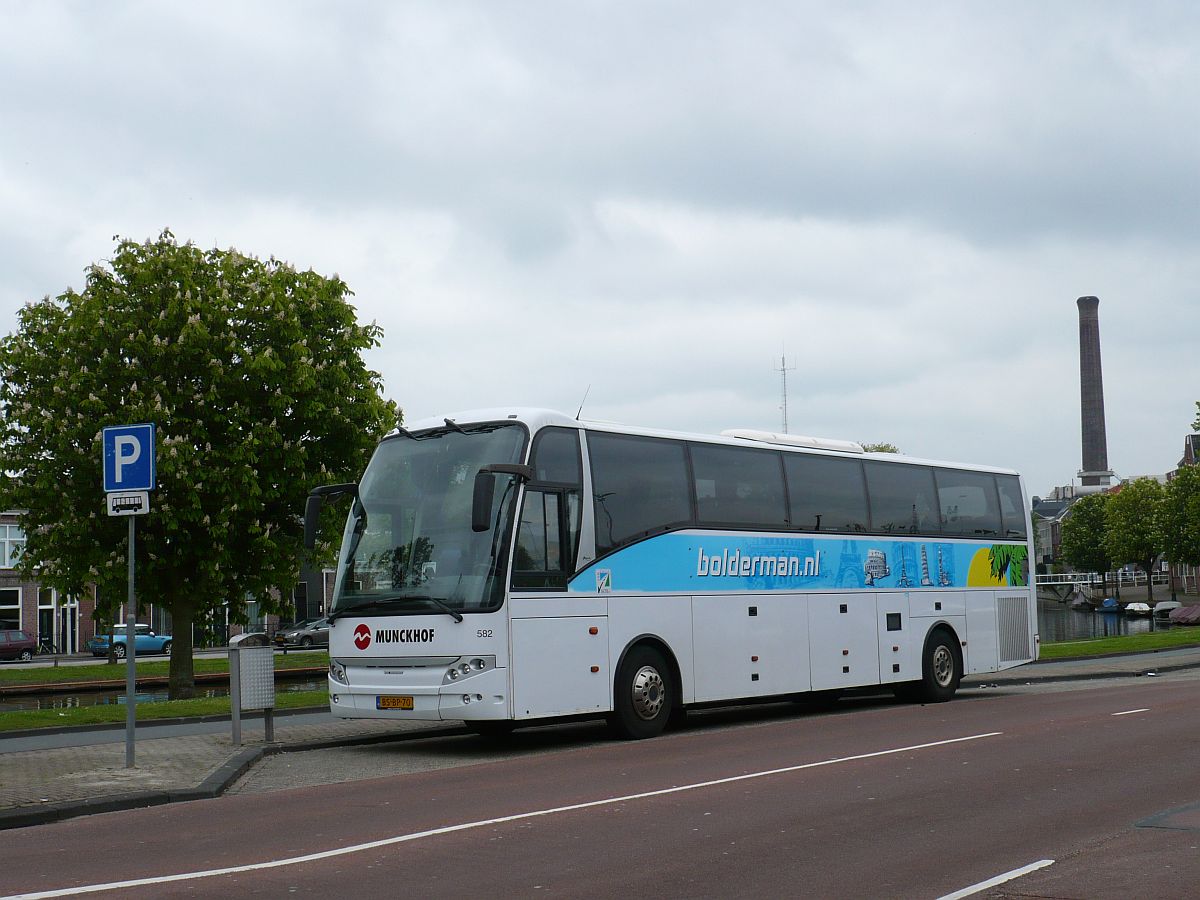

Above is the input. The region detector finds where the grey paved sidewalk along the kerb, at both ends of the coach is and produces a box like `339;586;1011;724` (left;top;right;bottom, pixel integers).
0;648;1200;829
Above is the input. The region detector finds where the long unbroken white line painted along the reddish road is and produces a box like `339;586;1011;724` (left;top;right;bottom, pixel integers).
0;731;1003;900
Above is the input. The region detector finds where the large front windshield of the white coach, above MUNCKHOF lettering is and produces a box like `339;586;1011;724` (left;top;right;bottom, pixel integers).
331;422;527;619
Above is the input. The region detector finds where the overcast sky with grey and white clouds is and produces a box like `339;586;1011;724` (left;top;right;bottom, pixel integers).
0;0;1200;494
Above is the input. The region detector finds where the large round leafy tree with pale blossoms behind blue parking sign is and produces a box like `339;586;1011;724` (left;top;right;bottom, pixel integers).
0;232;397;696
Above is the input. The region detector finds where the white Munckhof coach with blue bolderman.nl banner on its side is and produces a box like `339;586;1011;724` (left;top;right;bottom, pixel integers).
305;409;1039;738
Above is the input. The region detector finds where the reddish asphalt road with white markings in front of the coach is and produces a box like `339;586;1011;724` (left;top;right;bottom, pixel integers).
0;676;1200;899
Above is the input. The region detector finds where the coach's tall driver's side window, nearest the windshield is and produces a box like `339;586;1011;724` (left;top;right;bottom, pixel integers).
512;428;583;588
